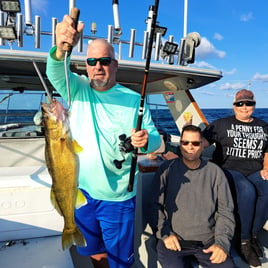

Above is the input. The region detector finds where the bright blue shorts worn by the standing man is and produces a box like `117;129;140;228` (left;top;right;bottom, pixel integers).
75;191;135;268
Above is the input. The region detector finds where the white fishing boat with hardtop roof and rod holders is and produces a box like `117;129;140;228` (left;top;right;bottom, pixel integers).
0;0;268;268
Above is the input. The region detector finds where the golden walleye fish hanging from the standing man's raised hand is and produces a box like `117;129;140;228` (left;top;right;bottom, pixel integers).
42;99;86;250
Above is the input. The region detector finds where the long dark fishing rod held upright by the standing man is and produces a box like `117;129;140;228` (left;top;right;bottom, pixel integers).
127;0;159;192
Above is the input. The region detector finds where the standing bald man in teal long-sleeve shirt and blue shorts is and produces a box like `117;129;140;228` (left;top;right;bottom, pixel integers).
47;15;161;268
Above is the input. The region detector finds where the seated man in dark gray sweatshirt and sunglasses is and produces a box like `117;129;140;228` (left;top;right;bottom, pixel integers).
151;125;235;268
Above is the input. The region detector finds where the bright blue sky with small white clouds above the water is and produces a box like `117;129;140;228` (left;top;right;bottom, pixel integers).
0;0;268;108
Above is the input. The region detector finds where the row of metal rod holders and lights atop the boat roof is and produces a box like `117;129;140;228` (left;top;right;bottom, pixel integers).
0;2;200;65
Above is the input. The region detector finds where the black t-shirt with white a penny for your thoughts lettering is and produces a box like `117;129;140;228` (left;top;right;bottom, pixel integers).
203;116;268;176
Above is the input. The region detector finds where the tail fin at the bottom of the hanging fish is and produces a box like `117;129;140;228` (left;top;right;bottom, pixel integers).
61;226;87;250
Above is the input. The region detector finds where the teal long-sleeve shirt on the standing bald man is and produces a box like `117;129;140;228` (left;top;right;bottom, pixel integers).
47;48;161;201
